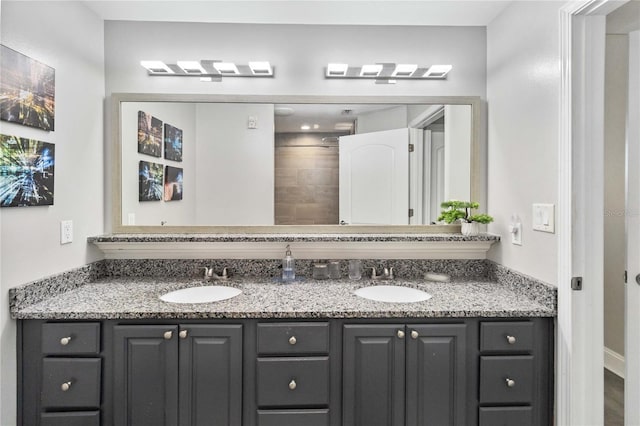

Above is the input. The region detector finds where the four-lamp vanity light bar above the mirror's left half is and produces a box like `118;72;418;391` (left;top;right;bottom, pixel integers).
140;60;274;81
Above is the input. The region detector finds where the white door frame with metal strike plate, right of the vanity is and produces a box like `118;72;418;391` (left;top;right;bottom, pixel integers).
556;0;626;426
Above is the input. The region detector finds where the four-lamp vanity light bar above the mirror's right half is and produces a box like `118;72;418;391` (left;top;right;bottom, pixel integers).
325;63;453;84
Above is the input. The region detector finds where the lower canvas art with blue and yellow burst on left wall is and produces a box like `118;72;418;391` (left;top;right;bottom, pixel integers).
0;135;55;207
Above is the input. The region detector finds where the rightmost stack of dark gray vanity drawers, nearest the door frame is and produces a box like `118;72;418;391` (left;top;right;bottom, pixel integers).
479;321;536;426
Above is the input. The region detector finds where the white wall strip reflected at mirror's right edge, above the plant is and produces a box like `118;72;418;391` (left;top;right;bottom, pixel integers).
444;105;472;202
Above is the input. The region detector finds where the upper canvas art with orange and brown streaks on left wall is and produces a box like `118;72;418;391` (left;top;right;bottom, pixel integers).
0;45;56;130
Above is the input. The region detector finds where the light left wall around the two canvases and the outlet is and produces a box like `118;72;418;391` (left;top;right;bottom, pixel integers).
0;0;104;426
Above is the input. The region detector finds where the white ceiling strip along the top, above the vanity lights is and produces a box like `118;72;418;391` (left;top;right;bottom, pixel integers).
85;0;511;26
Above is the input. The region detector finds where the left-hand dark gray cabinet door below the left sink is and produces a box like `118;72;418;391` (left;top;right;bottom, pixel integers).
113;325;178;426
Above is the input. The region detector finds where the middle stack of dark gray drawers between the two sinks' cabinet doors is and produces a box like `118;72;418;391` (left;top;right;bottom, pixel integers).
256;322;330;426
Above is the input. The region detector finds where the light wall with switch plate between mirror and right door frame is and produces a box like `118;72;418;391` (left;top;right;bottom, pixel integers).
487;1;564;284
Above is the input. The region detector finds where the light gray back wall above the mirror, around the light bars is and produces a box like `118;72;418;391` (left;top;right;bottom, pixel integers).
105;21;486;97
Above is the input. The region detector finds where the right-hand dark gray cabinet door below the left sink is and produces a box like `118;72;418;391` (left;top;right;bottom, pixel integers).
180;324;242;426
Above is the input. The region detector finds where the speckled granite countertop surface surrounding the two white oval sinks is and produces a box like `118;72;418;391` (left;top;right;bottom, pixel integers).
12;278;556;319
